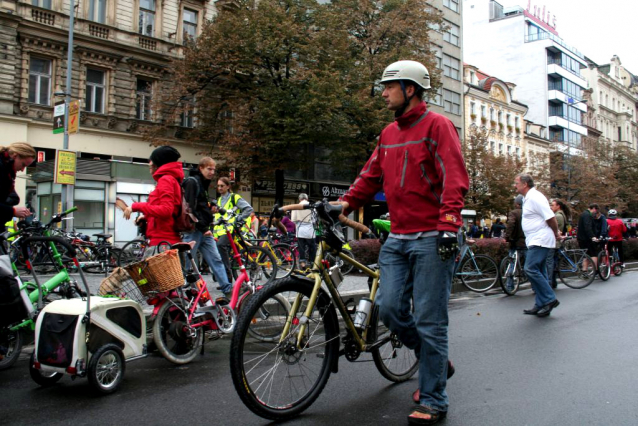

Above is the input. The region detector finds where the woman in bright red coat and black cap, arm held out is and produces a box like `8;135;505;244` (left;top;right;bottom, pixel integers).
124;145;184;246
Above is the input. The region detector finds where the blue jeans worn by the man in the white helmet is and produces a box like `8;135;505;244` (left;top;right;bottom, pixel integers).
376;237;454;411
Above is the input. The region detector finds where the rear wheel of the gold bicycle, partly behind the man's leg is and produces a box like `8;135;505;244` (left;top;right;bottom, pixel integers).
368;305;419;383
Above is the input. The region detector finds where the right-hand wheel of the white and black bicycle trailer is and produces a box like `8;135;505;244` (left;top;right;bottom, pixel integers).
88;343;126;395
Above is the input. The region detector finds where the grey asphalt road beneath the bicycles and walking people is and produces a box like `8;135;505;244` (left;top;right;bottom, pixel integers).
0;272;638;426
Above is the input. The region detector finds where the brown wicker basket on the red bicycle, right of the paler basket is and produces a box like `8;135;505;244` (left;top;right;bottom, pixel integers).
124;250;184;295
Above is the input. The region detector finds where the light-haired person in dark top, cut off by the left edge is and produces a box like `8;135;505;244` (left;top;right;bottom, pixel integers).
0;142;36;232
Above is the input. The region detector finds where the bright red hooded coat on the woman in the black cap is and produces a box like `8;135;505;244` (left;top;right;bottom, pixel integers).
131;161;184;246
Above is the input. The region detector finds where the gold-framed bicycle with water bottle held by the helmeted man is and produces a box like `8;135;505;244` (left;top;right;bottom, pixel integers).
230;200;418;420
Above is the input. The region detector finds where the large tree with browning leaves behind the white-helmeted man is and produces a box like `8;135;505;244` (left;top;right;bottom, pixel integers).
147;0;442;180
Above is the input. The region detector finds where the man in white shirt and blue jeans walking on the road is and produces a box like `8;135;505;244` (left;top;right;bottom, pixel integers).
514;173;560;317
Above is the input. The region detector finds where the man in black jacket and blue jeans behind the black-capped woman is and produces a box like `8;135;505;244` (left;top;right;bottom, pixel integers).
182;157;232;296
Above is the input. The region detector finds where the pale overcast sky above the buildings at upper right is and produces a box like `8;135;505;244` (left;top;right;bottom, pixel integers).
490;0;638;75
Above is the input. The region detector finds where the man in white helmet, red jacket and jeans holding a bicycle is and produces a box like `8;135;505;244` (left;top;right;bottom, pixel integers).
343;61;469;424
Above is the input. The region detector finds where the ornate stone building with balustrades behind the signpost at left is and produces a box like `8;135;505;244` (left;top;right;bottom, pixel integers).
0;0;215;241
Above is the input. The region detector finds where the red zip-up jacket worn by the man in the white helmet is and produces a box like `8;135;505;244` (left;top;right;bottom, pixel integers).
342;102;469;234
